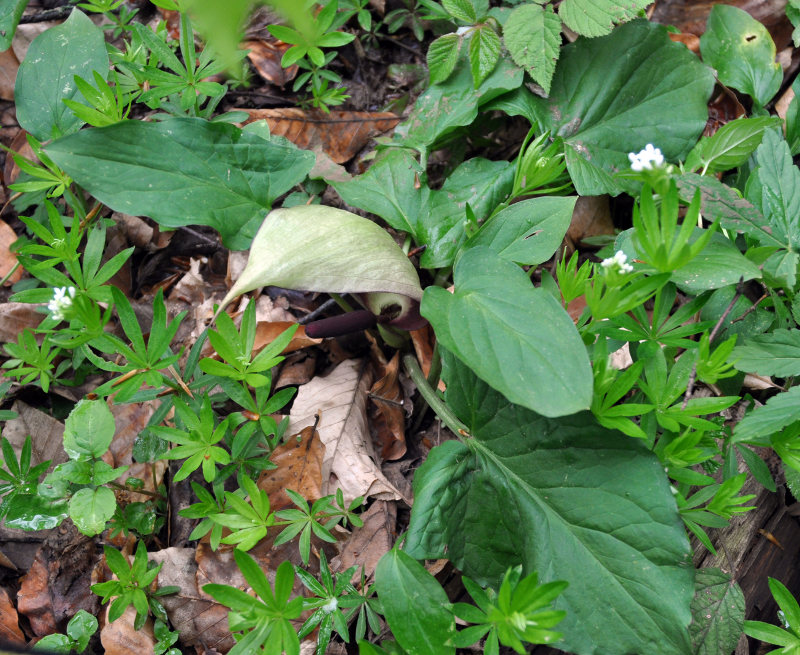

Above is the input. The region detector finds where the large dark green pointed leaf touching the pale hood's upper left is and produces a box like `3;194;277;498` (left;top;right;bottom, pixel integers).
46;118;314;250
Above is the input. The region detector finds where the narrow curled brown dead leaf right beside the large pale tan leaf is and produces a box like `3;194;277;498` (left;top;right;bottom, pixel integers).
369;341;406;460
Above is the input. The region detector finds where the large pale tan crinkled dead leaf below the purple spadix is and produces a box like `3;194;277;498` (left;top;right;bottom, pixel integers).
289;360;410;503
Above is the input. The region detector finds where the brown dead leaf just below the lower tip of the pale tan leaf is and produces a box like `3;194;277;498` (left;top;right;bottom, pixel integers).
331;500;397;583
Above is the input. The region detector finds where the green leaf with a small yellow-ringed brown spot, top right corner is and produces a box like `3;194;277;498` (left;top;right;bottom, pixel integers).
700;5;783;107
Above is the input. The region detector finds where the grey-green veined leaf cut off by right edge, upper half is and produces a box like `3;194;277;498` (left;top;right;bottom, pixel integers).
745;130;800;251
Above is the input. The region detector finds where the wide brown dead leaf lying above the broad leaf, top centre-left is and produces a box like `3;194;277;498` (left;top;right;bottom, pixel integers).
241;107;401;164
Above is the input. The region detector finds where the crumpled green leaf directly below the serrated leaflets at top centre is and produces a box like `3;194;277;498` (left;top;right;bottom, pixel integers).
395;53;524;152
